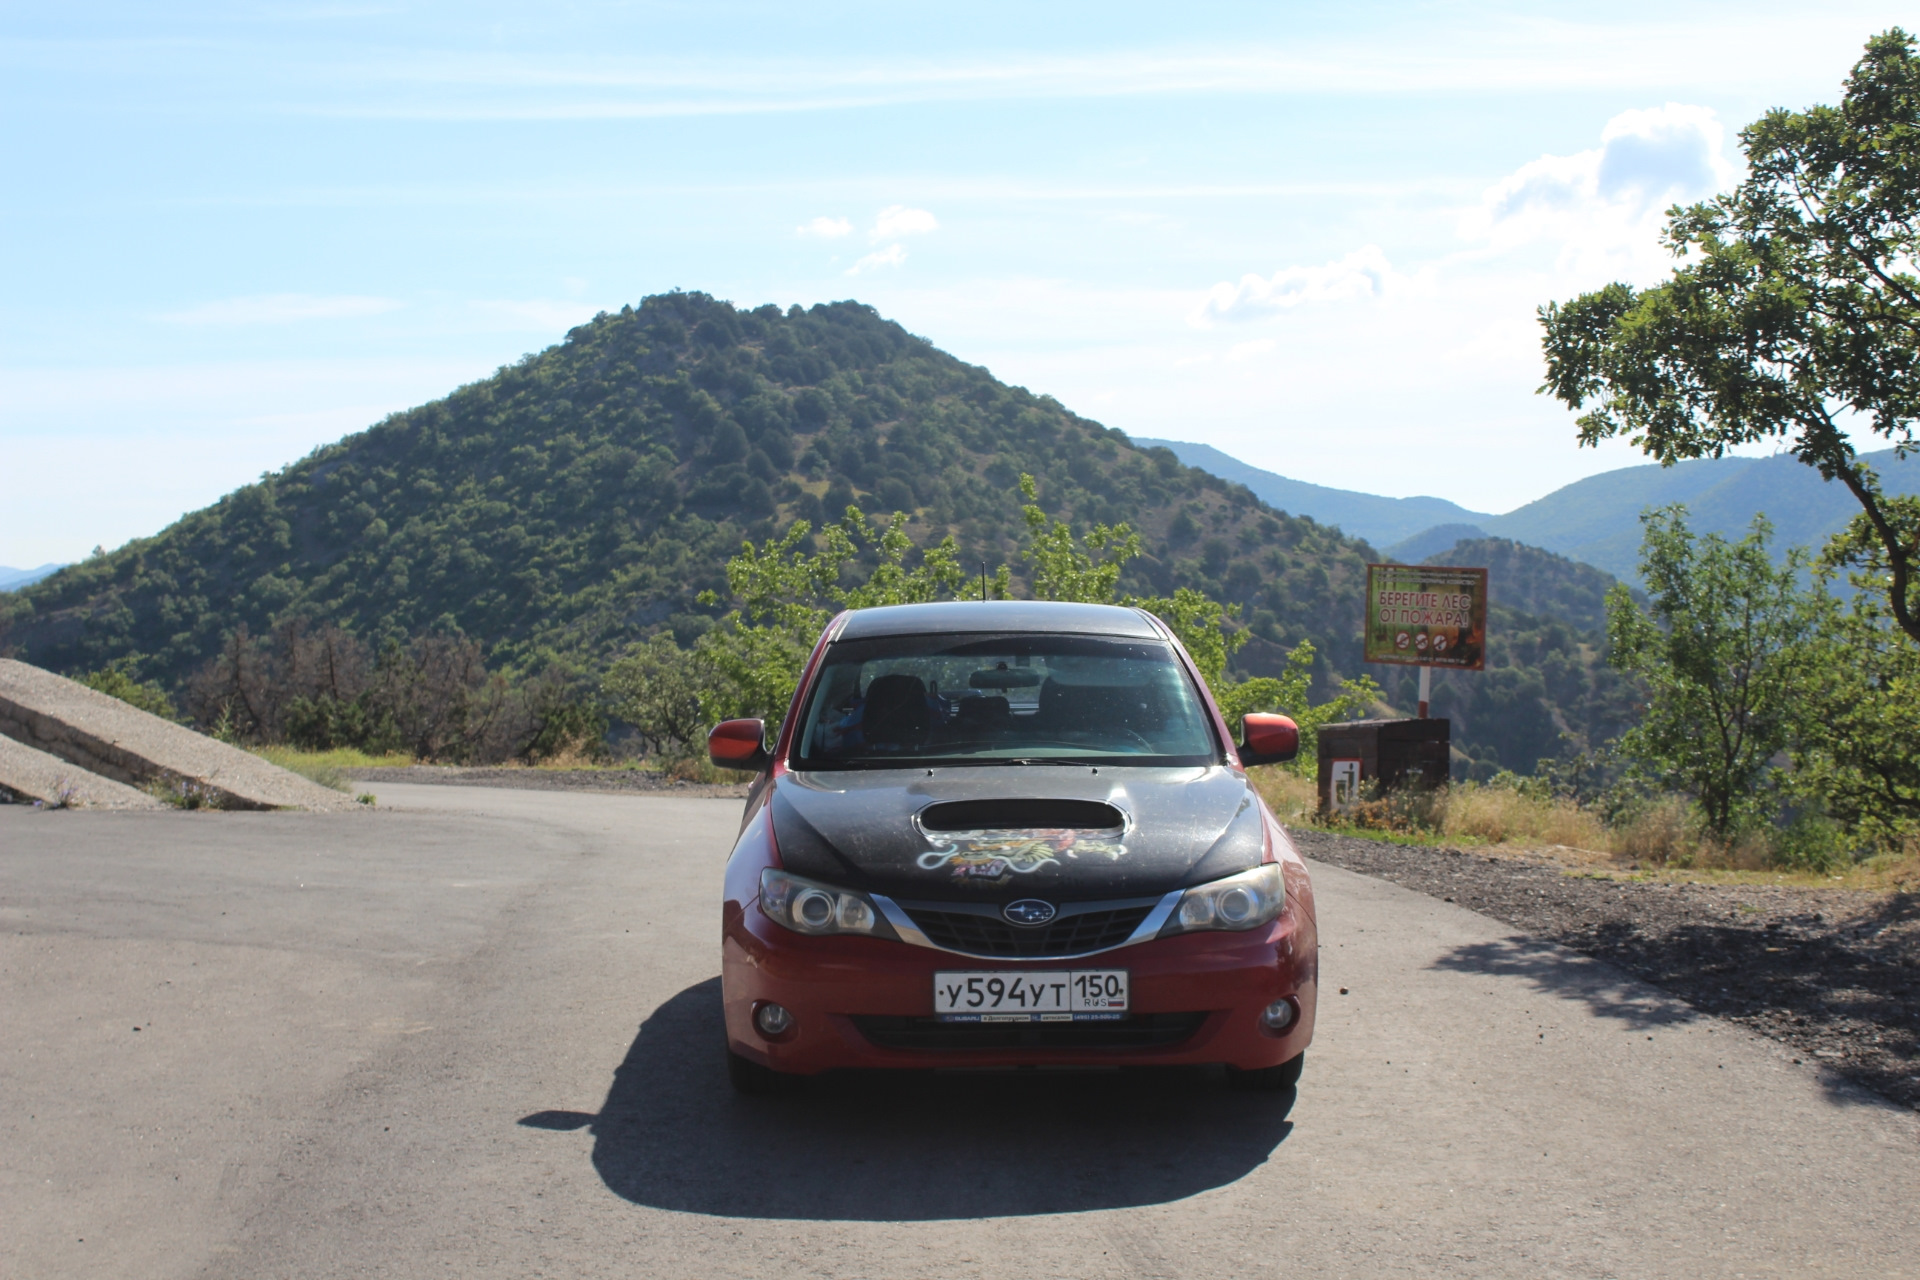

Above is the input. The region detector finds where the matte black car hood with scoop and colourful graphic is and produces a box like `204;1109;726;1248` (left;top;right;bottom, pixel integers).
770;766;1261;902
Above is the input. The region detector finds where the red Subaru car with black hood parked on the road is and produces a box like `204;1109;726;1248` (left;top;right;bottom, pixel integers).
708;601;1317;1092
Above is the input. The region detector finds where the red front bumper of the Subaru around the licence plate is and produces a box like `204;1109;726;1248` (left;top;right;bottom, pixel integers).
722;898;1319;1075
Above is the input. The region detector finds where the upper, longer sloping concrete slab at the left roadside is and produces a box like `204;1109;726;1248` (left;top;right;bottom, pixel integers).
0;658;359;812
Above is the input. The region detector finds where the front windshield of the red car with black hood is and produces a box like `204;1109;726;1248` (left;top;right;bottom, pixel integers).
795;633;1217;770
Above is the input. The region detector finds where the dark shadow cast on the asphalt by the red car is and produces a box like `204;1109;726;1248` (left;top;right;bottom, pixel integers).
520;979;1294;1222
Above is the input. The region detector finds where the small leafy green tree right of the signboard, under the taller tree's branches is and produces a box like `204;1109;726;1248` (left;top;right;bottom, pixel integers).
1607;507;1818;839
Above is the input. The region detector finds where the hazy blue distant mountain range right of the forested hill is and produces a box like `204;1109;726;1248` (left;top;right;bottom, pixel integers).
1137;439;1920;580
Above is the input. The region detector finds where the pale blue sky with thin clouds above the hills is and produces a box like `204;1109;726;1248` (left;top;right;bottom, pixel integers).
0;0;1914;564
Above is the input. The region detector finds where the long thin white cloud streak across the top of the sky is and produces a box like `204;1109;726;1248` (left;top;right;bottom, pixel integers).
303;17;1885;119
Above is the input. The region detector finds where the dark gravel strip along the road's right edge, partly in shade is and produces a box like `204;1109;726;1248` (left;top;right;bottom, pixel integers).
1292;829;1920;1109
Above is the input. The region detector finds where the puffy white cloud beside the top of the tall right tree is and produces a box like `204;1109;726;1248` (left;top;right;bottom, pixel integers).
1461;102;1738;276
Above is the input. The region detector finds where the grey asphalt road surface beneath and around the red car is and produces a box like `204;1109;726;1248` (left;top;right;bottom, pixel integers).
0;785;1920;1280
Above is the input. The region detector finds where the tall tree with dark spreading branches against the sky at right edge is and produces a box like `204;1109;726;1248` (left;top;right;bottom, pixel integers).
1540;29;1920;645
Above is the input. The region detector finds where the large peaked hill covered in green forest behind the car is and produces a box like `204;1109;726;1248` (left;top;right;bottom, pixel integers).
0;294;1635;760
